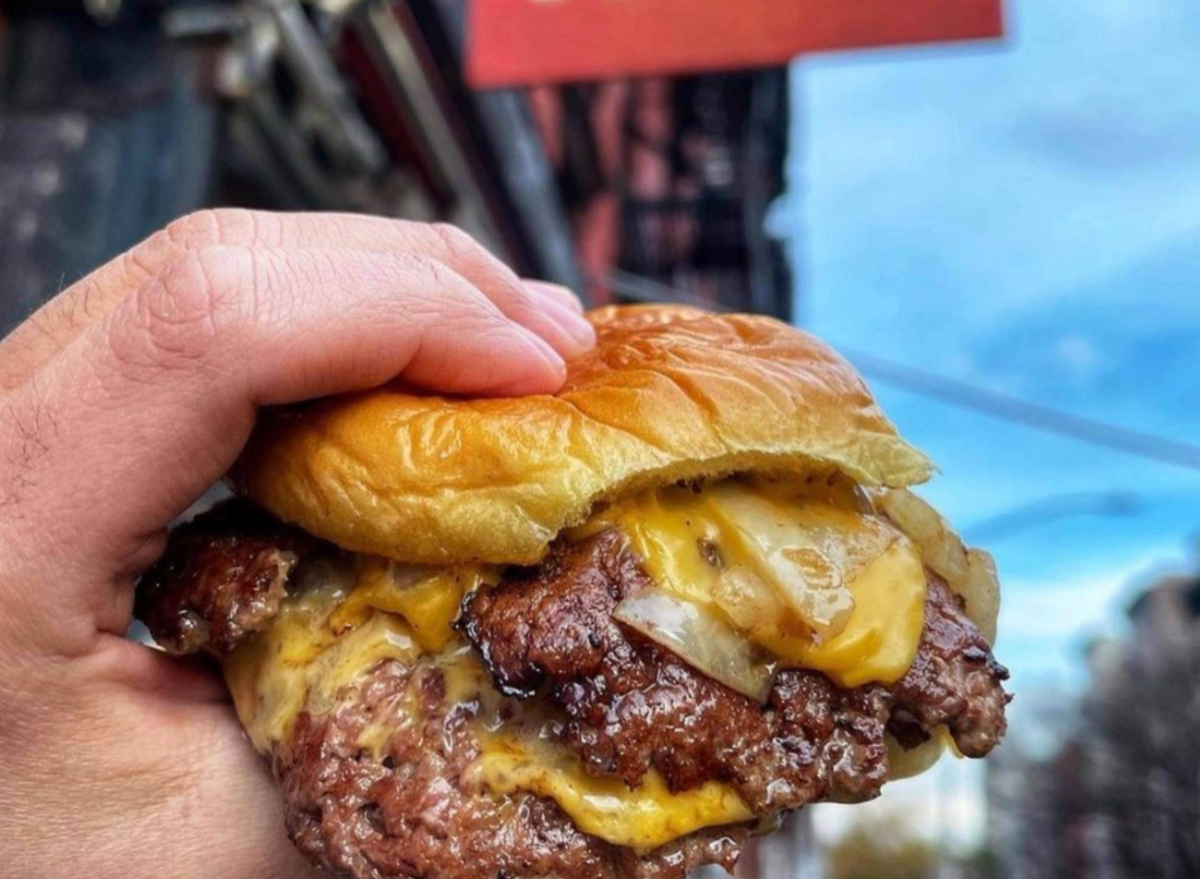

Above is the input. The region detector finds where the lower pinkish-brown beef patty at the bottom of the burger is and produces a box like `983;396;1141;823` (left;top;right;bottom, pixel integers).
282;660;750;879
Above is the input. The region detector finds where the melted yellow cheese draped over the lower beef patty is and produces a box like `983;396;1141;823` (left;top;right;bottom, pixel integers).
226;593;752;849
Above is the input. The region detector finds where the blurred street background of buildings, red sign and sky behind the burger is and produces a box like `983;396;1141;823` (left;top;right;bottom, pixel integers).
0;0;1200;879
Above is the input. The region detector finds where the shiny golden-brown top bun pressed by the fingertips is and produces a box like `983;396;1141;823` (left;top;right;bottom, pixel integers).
230;306;932;564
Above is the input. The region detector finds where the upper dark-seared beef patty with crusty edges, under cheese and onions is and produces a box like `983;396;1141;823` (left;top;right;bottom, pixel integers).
460;530;1008;814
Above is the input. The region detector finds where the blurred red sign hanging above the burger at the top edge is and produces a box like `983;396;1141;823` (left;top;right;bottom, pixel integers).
468;0;1003;86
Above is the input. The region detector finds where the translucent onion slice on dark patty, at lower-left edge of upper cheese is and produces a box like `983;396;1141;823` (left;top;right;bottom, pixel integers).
612;588;774;704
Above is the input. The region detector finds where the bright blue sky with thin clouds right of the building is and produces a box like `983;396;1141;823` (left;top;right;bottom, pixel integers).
773;0;1200;850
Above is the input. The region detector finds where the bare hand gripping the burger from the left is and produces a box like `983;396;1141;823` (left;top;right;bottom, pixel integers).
0;211;594;879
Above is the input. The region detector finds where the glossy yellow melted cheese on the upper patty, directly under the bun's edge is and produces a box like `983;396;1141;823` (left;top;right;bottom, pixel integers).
609;482;925;687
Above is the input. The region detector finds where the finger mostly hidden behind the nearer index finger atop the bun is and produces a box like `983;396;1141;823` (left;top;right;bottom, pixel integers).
0;209;594;389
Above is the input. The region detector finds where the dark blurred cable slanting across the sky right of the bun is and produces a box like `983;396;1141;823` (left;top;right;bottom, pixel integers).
840;347;1200;471
